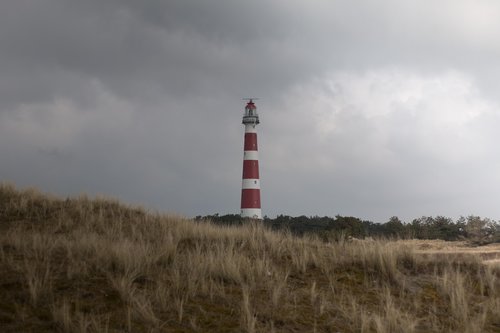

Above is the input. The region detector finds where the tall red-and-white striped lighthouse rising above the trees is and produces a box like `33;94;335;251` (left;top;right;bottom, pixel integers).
241;99;262;219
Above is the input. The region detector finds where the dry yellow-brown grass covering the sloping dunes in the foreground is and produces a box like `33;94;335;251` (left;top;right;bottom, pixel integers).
0;185;500;332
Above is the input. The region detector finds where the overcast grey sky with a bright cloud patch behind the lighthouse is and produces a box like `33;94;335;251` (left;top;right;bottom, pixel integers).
0;0;500;222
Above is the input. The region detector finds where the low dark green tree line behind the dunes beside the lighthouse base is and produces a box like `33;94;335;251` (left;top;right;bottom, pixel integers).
194;214;500;244
